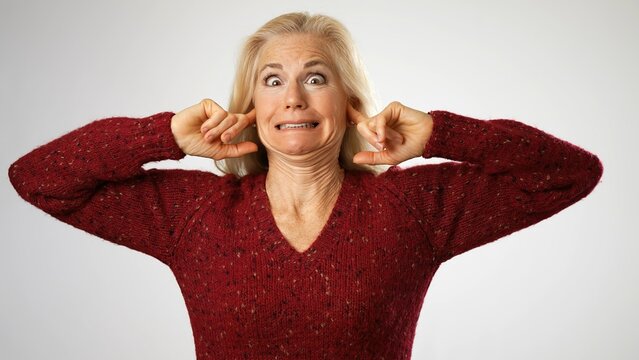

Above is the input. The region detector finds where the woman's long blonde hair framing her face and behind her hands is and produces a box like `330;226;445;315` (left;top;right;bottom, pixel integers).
215;12;380;177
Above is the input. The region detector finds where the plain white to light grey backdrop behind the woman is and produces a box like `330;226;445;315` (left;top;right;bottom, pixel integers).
0;0;639;359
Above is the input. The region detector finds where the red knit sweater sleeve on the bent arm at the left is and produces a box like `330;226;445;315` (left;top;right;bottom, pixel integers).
9;112;216;263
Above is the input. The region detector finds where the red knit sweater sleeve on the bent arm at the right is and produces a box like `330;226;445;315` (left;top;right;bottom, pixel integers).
384;111;603;262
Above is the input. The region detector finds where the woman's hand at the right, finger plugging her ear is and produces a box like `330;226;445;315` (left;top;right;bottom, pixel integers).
348;101;433;165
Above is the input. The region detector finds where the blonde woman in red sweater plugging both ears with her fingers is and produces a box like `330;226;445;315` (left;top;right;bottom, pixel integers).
9;13;602;359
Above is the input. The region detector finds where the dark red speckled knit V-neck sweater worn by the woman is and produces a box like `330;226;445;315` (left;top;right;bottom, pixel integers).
9;111;603;360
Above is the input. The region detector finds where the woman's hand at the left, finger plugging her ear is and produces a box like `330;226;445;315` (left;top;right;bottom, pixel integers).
171;99;257;160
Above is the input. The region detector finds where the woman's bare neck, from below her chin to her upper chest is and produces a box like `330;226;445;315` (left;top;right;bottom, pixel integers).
266;152;344;213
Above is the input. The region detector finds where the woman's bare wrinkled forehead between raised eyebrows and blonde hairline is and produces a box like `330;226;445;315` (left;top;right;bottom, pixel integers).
258;34;332;69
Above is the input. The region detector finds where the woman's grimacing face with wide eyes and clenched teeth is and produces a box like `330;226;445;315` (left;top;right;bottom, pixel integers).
253;34;348;157
